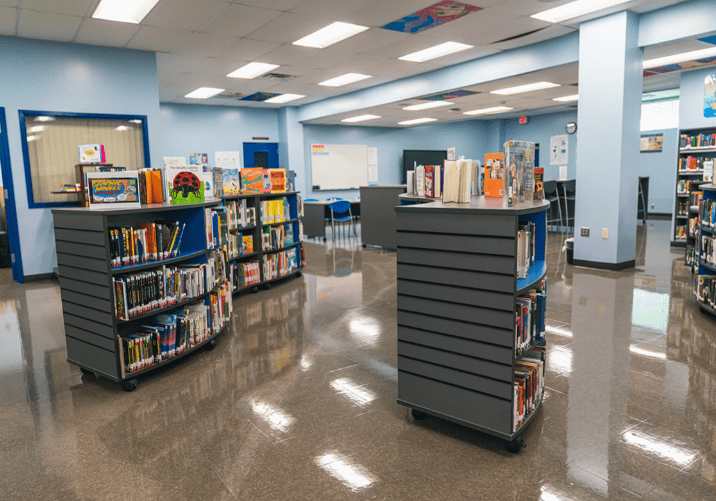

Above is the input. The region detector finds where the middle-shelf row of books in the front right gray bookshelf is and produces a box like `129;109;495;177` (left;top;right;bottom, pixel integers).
515;279;547;356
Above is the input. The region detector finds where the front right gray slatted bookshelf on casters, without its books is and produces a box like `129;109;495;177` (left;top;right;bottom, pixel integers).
395;196;549;452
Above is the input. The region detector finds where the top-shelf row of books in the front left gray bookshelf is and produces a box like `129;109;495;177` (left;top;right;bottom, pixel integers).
109;221;186;268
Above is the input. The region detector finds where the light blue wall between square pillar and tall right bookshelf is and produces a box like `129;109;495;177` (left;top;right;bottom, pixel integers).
639;129;679;214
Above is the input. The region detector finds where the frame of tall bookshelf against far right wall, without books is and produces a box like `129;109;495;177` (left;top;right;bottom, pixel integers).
671;127;716;247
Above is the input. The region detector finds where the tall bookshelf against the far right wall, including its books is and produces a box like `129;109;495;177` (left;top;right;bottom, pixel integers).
671;127;716;247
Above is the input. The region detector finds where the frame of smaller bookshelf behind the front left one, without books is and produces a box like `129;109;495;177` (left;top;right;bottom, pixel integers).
221;191;302;294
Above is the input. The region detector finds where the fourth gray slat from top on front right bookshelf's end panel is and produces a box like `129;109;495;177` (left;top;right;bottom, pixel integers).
398;264;515;293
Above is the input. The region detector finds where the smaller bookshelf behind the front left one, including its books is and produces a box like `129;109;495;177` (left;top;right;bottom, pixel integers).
221;191;303;294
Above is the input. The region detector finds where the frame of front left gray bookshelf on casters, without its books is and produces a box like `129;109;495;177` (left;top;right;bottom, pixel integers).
52;200;226;391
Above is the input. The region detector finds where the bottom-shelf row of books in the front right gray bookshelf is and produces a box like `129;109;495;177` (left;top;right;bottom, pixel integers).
512;354;544;432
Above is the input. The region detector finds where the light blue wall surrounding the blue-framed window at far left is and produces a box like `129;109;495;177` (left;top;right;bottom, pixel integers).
0;37;162;276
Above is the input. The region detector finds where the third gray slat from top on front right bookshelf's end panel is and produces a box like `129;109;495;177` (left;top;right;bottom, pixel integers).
398;248;515;275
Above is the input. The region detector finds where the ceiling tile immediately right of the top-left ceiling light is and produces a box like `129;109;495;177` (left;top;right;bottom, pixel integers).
143;0;229;31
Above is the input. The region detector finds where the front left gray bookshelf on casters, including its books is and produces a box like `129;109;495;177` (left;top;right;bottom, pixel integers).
52;200;231;391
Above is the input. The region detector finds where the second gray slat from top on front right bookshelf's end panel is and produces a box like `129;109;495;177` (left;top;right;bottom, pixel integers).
398;231;516;256
